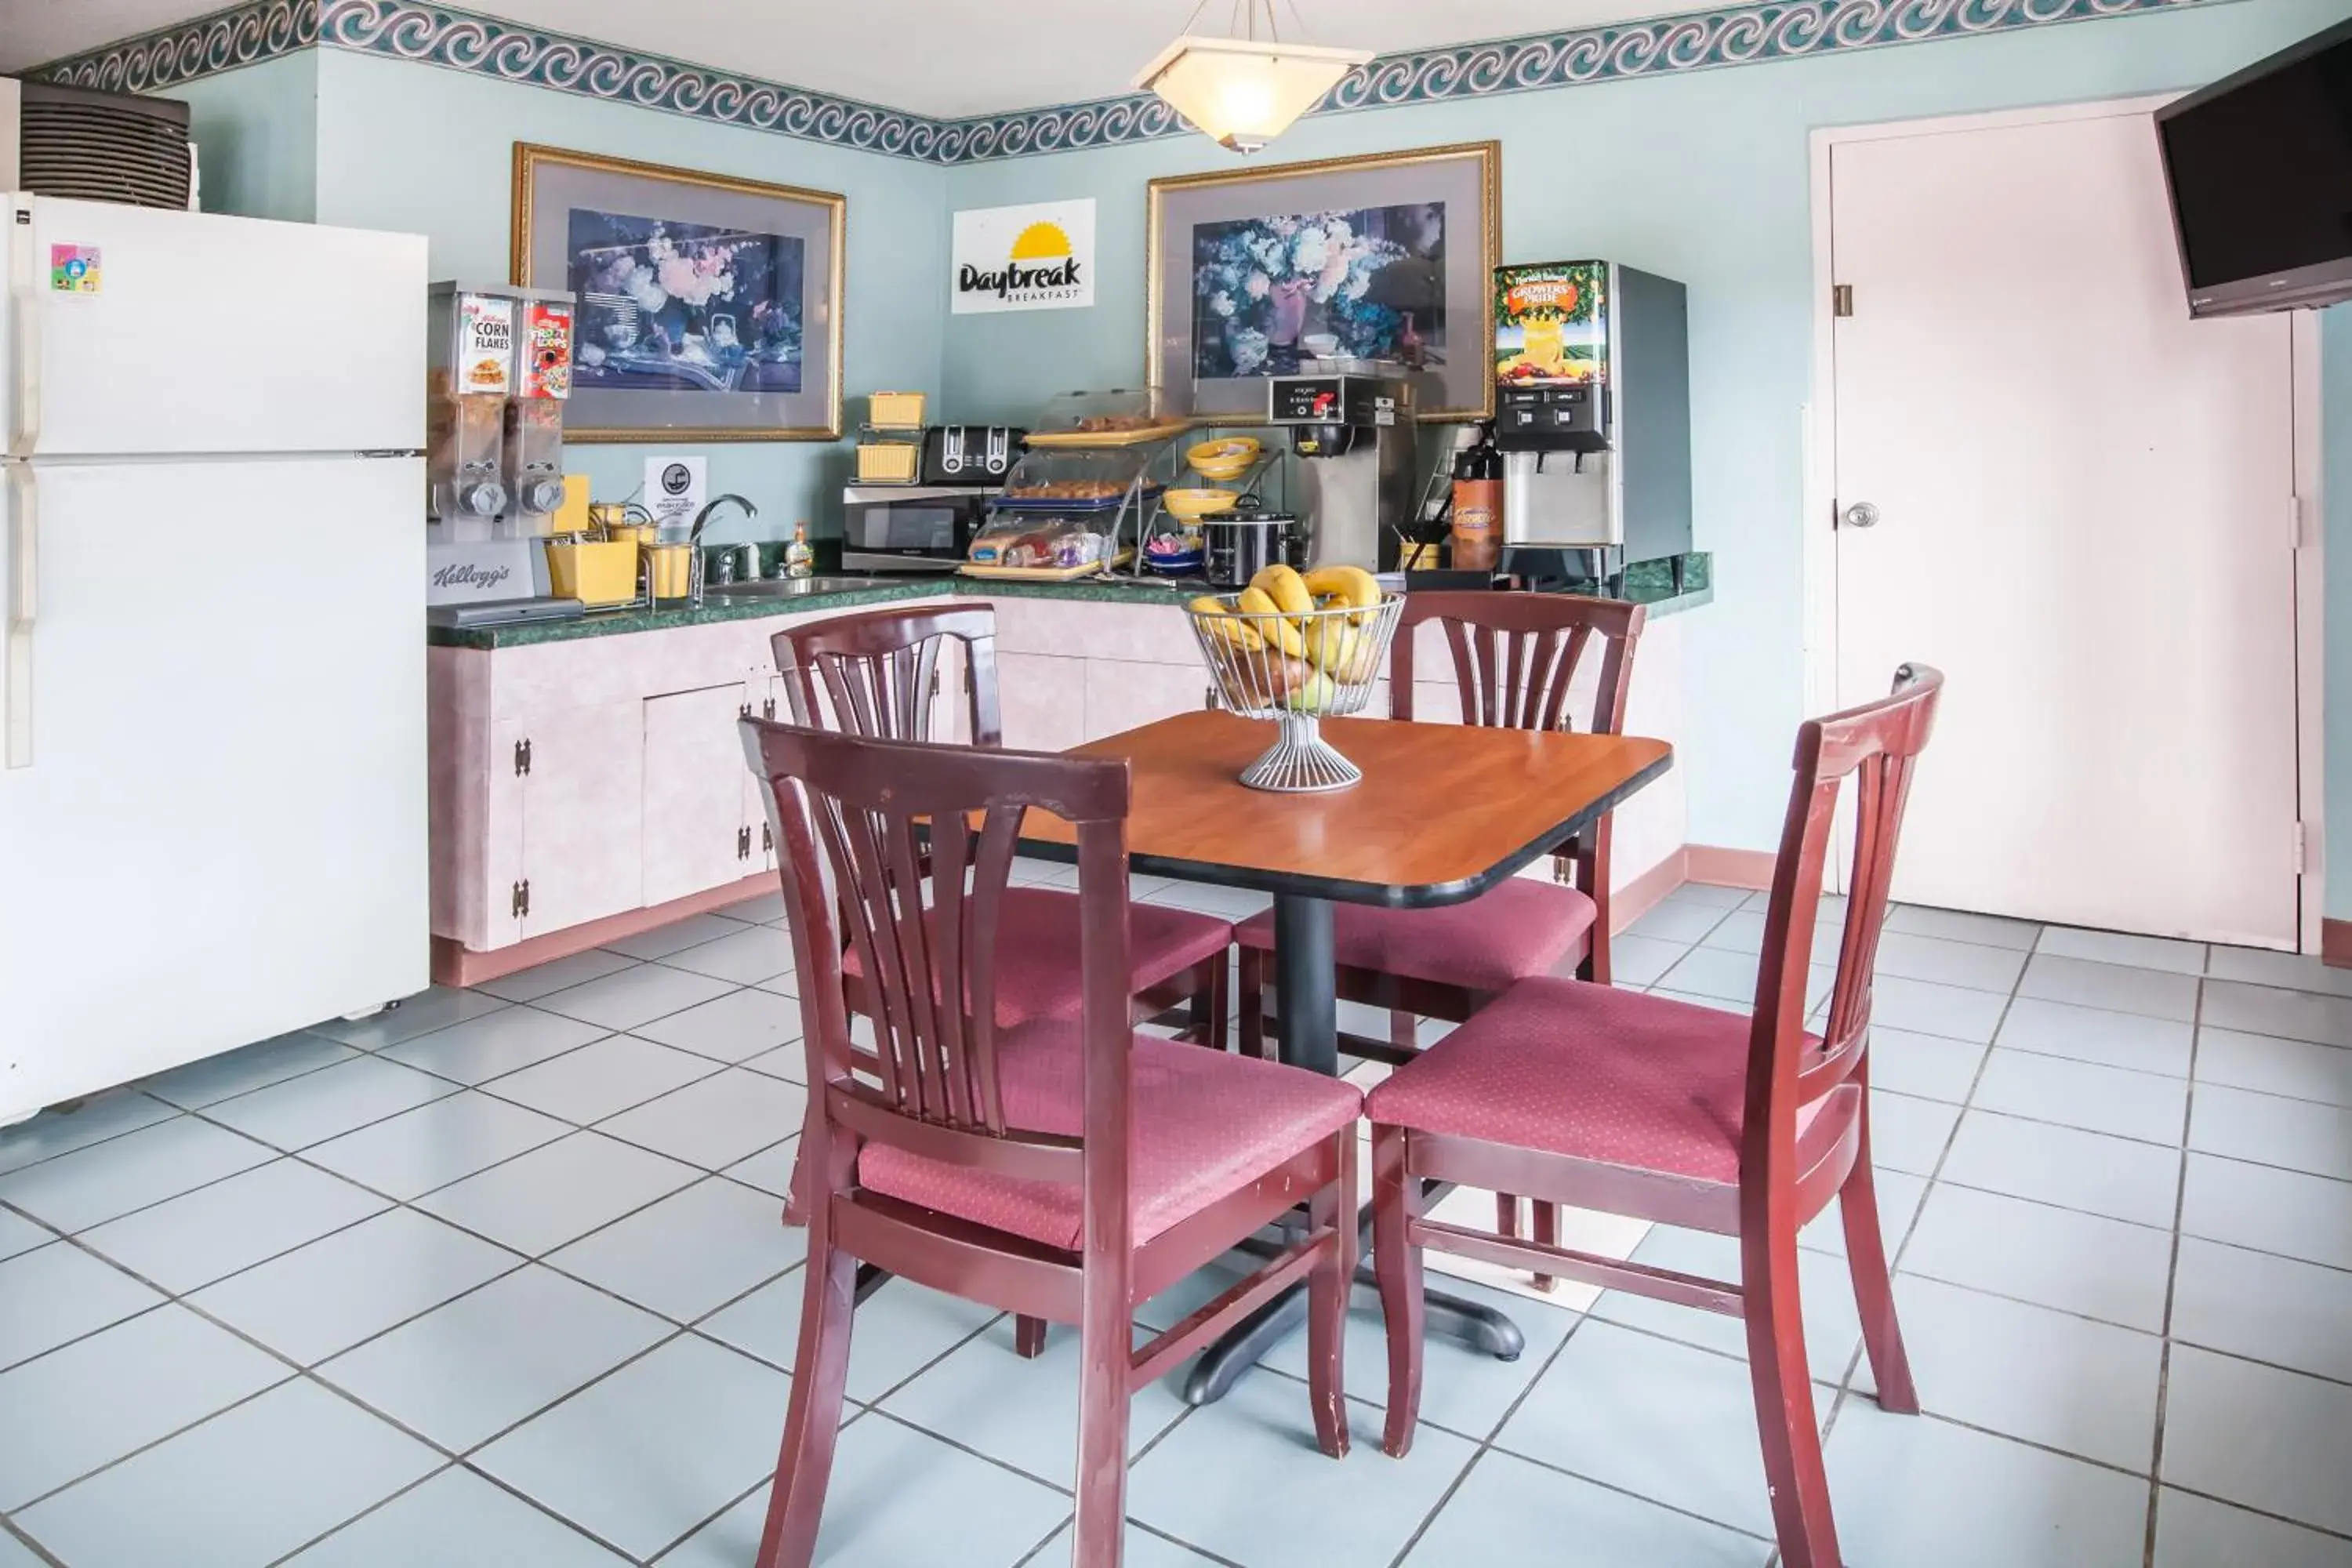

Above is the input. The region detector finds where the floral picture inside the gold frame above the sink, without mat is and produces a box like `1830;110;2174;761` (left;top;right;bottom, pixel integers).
567;207;807;393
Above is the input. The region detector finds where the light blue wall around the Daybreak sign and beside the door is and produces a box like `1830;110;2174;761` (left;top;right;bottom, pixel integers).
941;0;2352;860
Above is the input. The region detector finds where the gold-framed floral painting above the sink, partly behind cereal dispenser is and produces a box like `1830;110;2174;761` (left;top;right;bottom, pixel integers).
510;141;847;442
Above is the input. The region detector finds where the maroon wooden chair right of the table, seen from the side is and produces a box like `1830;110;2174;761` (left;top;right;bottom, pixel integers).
1367;666;1943;1568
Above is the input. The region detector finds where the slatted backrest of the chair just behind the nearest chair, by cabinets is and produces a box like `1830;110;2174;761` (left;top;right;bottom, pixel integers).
771;604;1004;746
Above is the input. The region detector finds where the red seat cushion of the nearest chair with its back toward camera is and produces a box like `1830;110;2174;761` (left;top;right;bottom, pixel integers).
858;1020;1364;1248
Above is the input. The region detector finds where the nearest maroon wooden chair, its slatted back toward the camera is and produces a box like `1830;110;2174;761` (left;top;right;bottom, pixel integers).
743;720;1362;1568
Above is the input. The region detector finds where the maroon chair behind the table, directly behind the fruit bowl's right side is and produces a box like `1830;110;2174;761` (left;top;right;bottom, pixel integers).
1232;593;1649;1288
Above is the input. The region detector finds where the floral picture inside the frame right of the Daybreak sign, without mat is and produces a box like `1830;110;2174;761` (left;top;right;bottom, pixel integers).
1192;202;1446;379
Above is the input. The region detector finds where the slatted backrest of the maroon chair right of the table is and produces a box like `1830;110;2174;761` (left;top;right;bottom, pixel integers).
1743;666;1943;1168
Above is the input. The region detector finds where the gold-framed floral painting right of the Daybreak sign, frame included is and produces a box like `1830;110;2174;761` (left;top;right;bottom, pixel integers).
1145;141;1503;421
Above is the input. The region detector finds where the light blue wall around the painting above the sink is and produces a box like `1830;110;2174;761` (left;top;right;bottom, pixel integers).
308;49;948;541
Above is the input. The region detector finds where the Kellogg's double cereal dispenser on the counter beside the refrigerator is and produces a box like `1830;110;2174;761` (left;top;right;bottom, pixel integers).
426;282;574;604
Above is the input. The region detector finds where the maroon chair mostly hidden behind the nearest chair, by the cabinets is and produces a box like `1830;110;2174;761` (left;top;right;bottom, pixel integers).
771;604;1232;1051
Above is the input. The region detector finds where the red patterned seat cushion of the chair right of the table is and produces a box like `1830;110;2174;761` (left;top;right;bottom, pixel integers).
1364;978;1811;1182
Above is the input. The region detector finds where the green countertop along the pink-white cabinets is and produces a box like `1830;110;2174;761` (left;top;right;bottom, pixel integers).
426;553;1715;649
